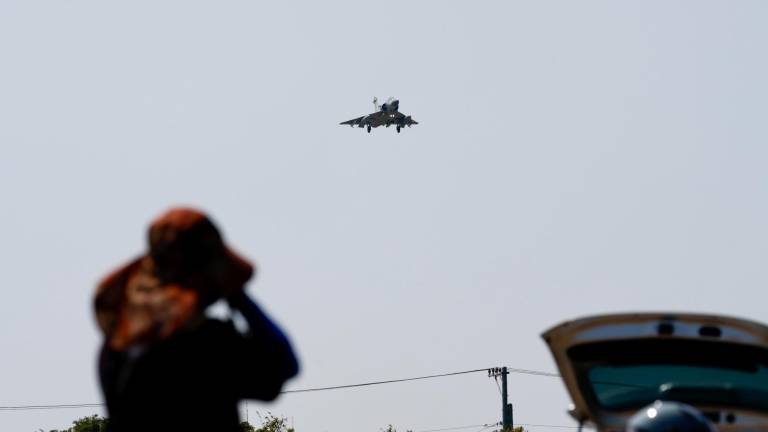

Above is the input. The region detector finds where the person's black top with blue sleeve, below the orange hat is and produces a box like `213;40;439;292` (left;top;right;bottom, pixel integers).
99;302;298;432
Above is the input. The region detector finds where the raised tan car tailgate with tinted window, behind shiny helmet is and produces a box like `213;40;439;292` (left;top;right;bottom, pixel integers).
542;313;768;431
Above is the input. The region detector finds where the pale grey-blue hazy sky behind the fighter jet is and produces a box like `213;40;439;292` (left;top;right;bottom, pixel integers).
0;0;768;432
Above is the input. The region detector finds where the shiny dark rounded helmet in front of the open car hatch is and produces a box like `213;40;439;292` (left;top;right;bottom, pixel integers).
627;401;716;432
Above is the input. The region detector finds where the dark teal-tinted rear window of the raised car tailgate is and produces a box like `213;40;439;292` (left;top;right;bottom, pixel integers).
568;338;768;411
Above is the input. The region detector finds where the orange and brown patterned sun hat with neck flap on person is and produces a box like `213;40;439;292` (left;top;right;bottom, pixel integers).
94;208;254;349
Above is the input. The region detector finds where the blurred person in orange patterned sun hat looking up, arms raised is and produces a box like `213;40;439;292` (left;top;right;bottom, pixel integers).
94;209;298;432
